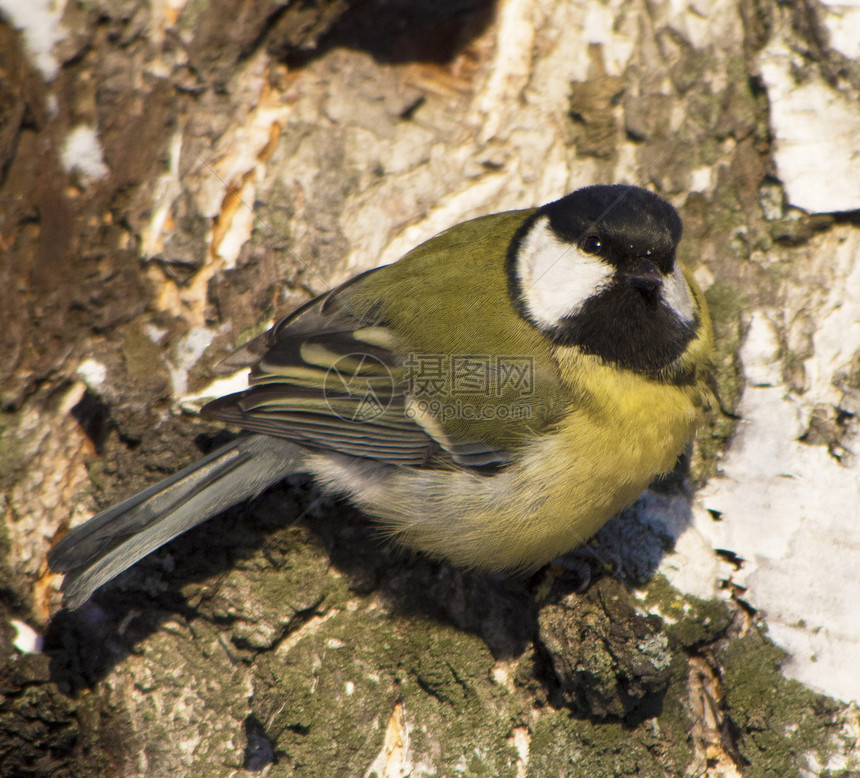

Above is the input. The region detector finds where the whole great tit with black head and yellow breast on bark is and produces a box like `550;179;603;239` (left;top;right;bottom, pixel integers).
48;185;715;608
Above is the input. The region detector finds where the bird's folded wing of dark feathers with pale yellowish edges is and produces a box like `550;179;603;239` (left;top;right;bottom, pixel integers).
201;268;508;468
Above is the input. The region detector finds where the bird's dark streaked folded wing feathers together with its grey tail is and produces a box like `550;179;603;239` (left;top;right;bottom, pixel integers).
48;271;506;608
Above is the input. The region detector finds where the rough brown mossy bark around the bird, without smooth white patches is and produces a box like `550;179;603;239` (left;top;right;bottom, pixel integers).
0;0;860;778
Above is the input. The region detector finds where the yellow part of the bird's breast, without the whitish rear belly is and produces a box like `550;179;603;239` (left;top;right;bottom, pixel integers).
444;360;706;568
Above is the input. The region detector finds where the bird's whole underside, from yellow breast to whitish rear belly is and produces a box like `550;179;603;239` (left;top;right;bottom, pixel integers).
310;355;703;570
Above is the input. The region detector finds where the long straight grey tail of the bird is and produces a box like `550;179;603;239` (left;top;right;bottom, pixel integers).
48;435;303;609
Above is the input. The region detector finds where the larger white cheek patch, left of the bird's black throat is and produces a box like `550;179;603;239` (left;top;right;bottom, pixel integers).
516;216;614;327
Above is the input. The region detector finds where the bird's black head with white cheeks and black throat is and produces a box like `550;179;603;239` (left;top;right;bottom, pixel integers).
508;185;698;373
